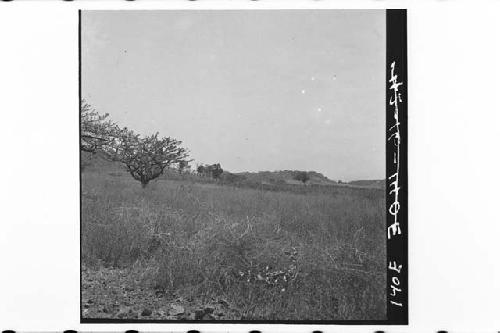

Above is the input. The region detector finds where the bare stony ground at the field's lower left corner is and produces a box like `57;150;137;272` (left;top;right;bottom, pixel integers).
81;268;241;320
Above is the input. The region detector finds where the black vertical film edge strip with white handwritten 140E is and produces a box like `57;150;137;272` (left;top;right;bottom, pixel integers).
386;10;408;325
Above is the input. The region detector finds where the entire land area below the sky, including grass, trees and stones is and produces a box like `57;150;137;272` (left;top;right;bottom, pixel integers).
81;100;386;320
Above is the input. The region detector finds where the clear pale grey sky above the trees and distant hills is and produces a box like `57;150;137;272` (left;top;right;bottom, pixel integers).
81;10;385;181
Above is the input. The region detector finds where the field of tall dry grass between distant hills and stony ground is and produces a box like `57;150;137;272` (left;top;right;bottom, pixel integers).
81;162;386;320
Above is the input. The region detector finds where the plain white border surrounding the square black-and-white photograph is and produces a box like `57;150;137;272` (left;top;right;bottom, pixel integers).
0;0;500;332
